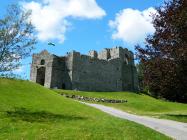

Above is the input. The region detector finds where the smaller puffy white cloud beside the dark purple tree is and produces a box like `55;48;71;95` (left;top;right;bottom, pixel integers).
109;7;156;45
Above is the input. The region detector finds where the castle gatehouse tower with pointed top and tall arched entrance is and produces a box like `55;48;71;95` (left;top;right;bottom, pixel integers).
30;50;71;89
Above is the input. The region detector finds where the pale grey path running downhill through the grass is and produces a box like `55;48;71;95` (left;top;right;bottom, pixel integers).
82;102;187;140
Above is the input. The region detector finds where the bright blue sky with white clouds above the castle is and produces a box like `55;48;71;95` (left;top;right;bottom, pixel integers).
0;0;164;79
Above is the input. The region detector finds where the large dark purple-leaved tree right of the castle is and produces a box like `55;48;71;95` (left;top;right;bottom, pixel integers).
136;0;187;102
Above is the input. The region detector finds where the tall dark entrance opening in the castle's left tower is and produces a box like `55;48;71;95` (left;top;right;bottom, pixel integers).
36;67;45;86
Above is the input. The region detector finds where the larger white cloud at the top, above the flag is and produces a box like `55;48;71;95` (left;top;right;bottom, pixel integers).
22;0;106;42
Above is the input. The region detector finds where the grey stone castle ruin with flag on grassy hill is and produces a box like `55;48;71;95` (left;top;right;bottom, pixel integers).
31;47;138;91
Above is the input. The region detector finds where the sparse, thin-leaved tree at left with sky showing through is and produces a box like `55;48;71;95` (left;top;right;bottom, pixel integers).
0;5;36;72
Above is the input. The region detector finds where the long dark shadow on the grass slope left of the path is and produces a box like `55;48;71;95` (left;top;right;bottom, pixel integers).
6;108;86;122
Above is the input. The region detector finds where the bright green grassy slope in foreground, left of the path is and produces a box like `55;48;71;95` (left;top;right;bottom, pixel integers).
0;79;169;140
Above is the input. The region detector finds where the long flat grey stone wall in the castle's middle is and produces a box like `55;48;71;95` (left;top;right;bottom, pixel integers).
72;54;122;91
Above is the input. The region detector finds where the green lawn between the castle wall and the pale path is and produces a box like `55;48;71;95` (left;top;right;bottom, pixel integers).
55;90;187;122
